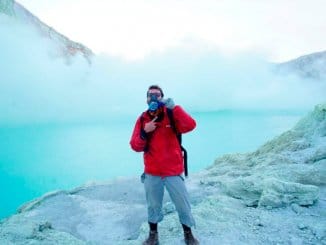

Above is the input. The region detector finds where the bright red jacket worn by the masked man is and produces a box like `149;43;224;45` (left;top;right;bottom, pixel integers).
130;105;196;177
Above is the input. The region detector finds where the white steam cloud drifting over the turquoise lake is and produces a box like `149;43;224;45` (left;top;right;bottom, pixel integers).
0;15;326;124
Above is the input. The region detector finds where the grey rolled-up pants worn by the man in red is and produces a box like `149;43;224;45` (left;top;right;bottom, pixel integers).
143;174;195;227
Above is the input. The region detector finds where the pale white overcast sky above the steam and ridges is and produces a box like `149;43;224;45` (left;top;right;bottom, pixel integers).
18;0;326;61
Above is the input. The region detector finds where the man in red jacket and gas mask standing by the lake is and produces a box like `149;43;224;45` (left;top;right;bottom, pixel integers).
130;85;199;245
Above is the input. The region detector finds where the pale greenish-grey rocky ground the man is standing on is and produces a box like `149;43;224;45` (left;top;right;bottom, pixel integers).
0;104;326;245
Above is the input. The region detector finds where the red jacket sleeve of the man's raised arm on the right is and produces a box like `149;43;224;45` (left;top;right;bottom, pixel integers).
173;105;196;134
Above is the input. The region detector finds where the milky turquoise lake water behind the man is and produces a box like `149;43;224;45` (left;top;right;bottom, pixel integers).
0;111;304;218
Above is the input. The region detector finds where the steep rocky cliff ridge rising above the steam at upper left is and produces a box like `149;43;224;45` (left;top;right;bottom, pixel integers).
0;0;93;62
